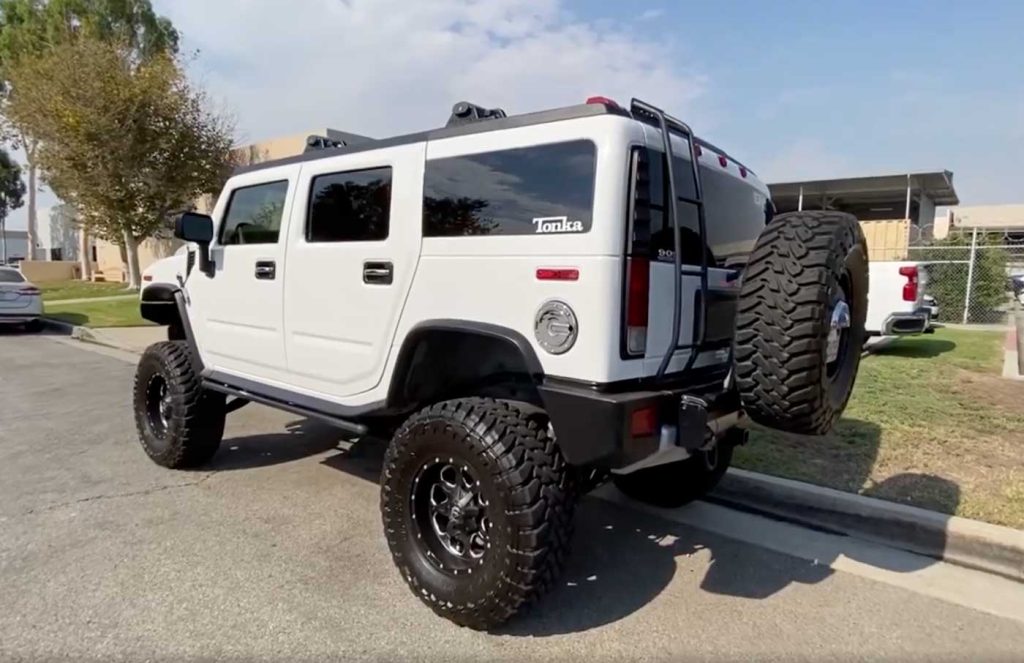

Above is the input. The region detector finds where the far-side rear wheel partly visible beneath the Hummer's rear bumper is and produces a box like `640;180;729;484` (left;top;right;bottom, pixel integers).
613;441;733;508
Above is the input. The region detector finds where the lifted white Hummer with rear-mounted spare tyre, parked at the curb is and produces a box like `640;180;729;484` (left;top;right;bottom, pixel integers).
134;97;867;628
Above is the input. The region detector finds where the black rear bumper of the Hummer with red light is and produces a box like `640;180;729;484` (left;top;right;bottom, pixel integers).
539;373;743;473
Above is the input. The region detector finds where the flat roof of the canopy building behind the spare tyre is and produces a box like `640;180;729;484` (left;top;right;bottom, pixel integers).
768;170;959;207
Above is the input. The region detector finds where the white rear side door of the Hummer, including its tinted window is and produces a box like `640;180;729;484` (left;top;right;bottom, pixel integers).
285;143;426;398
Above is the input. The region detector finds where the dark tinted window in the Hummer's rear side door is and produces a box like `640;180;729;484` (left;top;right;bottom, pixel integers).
306;168;391;242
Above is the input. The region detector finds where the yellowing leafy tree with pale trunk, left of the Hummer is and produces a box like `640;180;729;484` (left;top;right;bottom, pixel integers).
7;38;232;287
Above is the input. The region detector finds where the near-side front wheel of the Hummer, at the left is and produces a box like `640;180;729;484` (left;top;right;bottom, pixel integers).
134;341;225;468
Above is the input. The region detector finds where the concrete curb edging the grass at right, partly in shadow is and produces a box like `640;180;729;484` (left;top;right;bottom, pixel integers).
709;469;1024;580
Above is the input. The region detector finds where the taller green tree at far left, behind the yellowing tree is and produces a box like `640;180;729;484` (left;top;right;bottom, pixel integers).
0;0;178;258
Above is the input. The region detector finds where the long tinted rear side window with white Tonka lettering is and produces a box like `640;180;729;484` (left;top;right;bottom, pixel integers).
423;140;597;237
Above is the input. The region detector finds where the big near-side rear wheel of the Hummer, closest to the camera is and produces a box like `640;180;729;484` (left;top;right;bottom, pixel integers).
381;399;575;629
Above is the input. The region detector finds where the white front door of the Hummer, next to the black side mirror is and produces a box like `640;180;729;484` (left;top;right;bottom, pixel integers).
188;167;298;381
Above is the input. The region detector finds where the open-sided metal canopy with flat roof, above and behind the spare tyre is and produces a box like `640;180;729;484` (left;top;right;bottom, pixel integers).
768;170;959;223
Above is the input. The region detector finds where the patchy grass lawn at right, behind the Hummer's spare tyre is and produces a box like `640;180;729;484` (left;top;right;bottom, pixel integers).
735;329;1024;528
